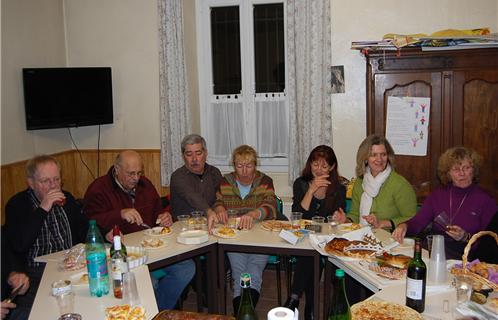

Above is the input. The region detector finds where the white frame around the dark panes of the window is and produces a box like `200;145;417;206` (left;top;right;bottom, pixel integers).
196;0;290;172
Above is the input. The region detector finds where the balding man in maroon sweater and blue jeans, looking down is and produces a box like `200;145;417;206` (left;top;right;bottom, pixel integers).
83;150;195;310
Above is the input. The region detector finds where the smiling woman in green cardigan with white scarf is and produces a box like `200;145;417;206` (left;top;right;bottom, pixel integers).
334;135;417;232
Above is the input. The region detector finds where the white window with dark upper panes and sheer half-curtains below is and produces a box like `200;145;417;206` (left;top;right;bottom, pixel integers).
196;0;289;172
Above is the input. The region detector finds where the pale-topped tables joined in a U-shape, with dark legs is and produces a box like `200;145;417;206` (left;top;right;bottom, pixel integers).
30;222;482;320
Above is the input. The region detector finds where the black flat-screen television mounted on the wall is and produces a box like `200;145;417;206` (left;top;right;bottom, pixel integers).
22;67;113;130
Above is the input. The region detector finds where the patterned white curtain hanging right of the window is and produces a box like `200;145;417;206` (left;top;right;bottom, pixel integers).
286;0;332;185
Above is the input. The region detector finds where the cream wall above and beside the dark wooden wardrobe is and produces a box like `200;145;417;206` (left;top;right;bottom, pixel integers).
331;0;498;178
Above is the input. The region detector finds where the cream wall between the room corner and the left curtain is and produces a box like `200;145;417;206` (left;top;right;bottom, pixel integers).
64;0;160;149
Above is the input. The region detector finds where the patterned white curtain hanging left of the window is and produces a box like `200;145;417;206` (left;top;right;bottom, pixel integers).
157;0;190;186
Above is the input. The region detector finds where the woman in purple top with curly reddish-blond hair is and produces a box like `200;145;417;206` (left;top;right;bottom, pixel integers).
392;147;497;259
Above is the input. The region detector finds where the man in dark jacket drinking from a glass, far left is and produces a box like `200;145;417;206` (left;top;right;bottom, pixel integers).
2;155;88;319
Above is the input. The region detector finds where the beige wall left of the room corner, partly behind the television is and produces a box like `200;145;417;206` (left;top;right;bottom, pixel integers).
1;0;71;164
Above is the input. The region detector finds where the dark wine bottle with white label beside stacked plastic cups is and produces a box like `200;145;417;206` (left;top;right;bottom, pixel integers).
406;238;427;313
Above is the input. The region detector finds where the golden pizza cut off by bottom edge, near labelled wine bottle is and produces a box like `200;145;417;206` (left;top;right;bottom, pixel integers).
351;300;422;320
